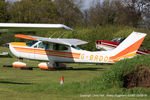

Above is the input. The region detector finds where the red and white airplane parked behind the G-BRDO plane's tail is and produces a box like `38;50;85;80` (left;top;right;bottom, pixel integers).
95;38;150;55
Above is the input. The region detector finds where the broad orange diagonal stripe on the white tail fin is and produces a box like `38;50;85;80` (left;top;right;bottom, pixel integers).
110;37;145;60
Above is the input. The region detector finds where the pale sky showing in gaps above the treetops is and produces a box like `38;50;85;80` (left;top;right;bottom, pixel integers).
6;0;96;9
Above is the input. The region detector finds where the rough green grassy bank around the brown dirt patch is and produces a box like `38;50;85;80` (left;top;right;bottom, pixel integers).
55;55;150;99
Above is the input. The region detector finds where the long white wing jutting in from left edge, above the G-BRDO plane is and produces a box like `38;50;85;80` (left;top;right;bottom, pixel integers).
0;23;72;31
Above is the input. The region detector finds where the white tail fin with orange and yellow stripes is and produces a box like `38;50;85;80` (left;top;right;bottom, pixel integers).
109;32;146;62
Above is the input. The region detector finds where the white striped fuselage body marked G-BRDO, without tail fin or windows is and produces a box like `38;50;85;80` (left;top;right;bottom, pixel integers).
9;41;113;63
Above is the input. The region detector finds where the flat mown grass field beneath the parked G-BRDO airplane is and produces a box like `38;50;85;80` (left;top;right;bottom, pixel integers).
0;47;149;100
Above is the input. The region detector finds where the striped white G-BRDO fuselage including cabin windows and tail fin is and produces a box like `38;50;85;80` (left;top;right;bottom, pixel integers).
9;32;146;63
